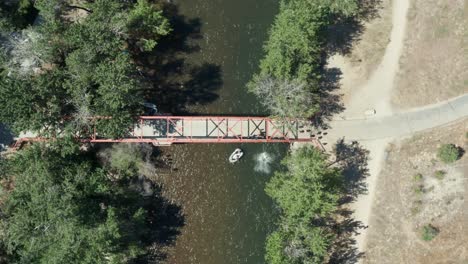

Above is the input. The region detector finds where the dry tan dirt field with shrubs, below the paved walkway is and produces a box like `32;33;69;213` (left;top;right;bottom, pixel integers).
364;120;468;263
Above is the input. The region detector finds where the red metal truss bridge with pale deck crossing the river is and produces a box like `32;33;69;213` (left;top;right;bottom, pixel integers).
18;116;322;145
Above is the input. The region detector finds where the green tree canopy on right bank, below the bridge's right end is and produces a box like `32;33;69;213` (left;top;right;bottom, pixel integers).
266;146;343;264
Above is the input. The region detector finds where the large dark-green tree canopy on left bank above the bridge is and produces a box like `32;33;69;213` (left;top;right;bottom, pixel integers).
0;0;171;137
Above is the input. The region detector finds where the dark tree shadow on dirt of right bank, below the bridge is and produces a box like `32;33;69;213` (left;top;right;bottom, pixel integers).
328;139;369;264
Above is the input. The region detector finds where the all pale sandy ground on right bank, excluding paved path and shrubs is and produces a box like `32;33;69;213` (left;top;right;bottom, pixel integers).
327;0;468;263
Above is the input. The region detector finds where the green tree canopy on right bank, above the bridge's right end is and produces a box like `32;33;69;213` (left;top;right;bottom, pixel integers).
248;0;358;118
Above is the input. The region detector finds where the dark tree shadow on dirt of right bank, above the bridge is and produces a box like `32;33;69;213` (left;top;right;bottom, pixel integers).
311;0;382;129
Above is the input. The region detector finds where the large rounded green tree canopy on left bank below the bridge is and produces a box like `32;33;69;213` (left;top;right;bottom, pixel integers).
0;141;168;264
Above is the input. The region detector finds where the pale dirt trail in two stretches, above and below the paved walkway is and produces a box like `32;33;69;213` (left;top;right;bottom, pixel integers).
329;0;409;255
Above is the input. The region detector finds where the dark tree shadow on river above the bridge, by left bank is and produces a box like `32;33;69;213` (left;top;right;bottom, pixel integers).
136;3;223;114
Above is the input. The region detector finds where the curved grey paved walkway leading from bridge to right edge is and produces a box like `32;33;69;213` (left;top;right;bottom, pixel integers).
327;94;468;142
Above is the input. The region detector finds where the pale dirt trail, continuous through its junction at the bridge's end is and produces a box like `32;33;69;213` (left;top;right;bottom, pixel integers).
326;0;409;260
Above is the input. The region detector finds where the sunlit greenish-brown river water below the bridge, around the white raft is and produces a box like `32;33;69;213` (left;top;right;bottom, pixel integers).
154;144;286;264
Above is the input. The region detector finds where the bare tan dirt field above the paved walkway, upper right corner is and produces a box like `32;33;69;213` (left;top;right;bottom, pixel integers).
392;0;468;109
